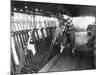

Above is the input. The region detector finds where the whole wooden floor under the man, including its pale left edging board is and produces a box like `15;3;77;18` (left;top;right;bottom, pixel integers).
39;49;95;72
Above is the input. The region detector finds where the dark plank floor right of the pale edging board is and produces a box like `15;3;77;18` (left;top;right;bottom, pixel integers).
48;50;93;72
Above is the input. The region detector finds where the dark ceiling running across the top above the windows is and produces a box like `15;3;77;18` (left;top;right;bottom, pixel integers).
11;1;96;17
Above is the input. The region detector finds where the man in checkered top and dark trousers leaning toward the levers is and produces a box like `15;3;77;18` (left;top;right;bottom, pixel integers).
55;15;75;54
